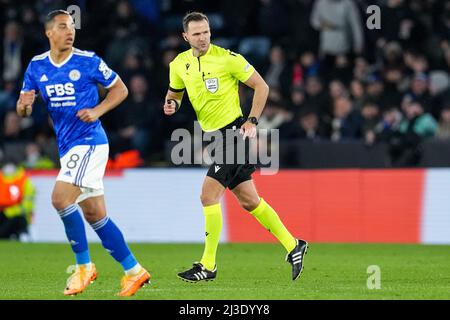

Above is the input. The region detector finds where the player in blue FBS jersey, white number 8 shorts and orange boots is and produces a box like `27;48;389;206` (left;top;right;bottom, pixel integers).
16;10;150;296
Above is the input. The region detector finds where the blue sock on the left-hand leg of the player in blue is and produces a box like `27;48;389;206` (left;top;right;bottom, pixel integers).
58;204;91;264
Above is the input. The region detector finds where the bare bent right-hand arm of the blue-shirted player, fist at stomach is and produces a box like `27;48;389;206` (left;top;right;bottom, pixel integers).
77;76;128;122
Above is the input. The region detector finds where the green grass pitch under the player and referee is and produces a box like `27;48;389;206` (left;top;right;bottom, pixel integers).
0;242;450;300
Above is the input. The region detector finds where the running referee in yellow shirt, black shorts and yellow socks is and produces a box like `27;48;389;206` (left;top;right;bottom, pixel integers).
164;12;308;282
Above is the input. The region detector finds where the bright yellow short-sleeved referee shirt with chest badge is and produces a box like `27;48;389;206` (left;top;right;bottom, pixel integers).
170;44;255;132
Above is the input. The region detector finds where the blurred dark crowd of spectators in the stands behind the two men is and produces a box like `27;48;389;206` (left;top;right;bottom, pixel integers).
0;0;450;168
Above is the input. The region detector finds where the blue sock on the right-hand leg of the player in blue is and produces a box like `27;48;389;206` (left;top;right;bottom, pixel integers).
91;216;137;271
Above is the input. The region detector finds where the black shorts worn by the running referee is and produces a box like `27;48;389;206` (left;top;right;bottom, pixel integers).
206;117;256;190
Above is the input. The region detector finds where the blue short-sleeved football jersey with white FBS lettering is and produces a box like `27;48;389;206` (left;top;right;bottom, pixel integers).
22;48;119;157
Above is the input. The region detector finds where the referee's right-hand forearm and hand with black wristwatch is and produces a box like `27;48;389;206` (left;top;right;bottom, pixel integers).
241;70;269;139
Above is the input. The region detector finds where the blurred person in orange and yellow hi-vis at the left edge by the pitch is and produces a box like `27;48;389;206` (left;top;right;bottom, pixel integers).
0;162;35;240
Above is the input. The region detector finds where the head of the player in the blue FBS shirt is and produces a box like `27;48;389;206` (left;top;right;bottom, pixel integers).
46;14;75;51
